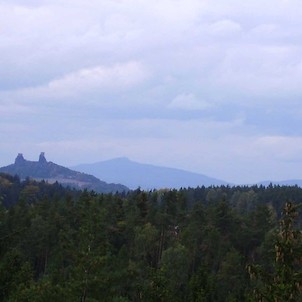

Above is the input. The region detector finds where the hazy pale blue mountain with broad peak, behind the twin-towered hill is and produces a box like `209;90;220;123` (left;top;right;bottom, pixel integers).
72;157;228;190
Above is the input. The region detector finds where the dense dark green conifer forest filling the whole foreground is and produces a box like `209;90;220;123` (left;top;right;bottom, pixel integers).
0;174;302;302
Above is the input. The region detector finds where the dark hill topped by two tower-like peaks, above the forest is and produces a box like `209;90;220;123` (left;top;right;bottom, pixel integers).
0;152;129;193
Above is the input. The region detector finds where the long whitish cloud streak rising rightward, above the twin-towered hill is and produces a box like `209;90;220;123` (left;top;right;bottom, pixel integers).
0;61;150;104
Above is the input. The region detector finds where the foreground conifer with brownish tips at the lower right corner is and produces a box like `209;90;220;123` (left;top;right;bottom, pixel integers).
248;202;302;302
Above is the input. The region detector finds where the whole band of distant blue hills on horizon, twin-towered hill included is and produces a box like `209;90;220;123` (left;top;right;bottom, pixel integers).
0;152;302;193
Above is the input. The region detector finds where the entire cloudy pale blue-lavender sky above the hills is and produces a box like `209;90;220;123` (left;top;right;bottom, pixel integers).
0;0;302;184
